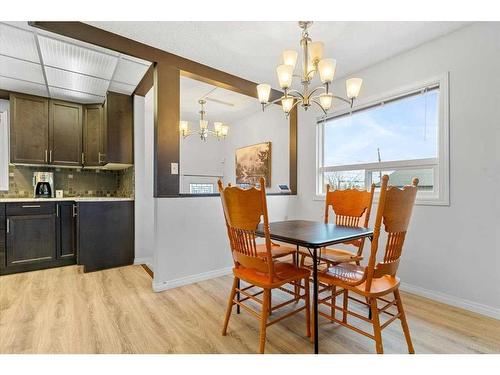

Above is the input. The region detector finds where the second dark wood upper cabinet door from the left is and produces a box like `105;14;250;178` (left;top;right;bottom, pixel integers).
49;100;82;166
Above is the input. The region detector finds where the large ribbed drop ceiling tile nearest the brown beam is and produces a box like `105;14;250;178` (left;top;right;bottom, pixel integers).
38;35;118;80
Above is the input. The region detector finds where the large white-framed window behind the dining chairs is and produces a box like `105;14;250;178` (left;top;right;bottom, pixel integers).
316;76;449;205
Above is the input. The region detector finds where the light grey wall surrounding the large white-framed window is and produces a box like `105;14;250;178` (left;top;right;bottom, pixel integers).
294;23;500;318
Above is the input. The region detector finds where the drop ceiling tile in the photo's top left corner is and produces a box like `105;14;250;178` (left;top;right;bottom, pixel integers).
0;24;40;63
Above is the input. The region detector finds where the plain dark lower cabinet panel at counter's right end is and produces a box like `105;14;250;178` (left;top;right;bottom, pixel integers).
77;201;134;272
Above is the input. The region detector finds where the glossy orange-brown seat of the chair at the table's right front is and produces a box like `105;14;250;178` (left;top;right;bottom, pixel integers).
318;263;400;297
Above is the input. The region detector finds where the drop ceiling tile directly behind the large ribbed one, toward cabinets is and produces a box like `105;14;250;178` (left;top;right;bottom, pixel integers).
45;67;109;96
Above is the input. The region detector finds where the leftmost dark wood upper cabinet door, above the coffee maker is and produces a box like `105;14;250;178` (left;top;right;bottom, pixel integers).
10;94;49;164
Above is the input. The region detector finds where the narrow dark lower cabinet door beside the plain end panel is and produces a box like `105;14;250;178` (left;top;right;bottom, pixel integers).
56;202;76;259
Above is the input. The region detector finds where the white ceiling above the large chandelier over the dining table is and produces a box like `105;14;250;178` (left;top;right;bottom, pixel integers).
85;21;469;88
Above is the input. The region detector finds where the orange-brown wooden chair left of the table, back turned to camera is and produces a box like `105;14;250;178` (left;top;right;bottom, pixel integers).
218;178;311;353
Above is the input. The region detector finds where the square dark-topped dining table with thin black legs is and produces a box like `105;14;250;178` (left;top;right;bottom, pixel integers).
256;220;373;354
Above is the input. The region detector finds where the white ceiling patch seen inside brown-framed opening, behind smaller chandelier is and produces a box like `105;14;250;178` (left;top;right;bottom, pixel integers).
180;77;262;126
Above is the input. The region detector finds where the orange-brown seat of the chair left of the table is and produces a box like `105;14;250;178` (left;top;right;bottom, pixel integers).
233;261;310;288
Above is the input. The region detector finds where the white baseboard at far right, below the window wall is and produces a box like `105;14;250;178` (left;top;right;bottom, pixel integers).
400;282;500;320
